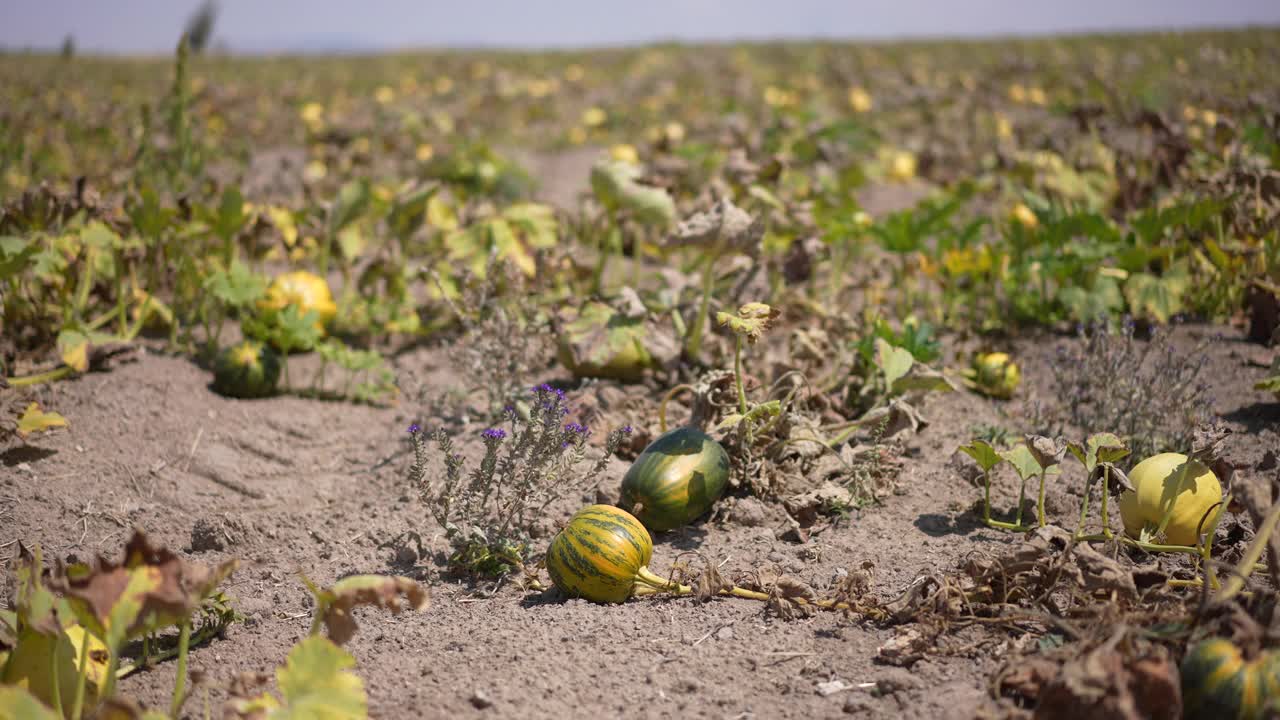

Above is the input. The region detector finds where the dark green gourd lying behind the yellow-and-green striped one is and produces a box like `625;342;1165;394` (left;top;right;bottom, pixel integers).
621;427;728;532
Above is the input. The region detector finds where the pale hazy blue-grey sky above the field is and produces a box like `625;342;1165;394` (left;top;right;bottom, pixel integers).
0;0;1280;53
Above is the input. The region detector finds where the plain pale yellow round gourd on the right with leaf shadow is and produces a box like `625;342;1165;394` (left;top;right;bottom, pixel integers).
1120;452;1222;546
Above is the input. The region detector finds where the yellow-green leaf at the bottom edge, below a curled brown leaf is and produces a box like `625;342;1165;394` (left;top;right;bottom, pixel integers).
268;635;369;720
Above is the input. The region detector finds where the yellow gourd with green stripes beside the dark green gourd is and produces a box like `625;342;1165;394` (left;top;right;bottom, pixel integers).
547;505;660;602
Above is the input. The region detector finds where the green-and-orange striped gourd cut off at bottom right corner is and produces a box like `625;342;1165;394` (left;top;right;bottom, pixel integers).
1181;638;1280;720
